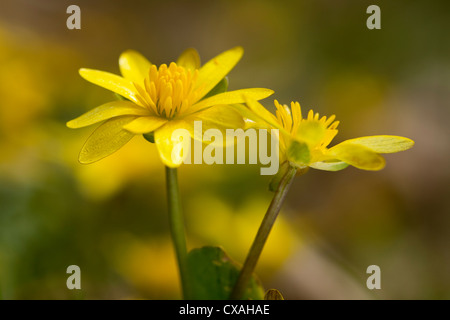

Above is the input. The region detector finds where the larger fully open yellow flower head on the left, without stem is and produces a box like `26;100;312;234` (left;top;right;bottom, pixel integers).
67;47;273;168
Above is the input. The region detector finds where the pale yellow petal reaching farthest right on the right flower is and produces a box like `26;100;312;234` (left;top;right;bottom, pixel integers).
343;135;414;153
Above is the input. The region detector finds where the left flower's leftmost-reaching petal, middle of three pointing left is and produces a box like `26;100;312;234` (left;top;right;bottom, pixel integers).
67;100;150;129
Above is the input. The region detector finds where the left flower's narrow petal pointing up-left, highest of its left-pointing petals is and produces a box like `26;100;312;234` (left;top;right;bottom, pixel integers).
79;68;141;105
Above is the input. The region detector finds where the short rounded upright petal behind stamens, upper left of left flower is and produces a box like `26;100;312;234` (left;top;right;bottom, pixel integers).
119;50;151;85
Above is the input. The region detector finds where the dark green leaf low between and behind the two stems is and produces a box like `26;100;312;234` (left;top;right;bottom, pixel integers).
187;247;264;300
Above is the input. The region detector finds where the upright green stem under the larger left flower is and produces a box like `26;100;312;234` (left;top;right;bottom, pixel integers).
166;167;189;299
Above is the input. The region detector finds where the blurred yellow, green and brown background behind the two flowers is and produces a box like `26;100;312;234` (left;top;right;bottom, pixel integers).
0;0;450;299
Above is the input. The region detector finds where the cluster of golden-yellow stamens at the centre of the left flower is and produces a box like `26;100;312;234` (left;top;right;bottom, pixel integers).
134;62;198;119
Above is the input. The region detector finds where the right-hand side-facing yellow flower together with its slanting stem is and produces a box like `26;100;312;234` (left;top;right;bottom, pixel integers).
231;98;414;299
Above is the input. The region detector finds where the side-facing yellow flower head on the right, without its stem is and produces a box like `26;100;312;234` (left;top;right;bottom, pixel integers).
245;99;414;171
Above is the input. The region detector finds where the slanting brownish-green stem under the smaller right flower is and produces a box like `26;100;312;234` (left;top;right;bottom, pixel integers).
230;167;297;300
